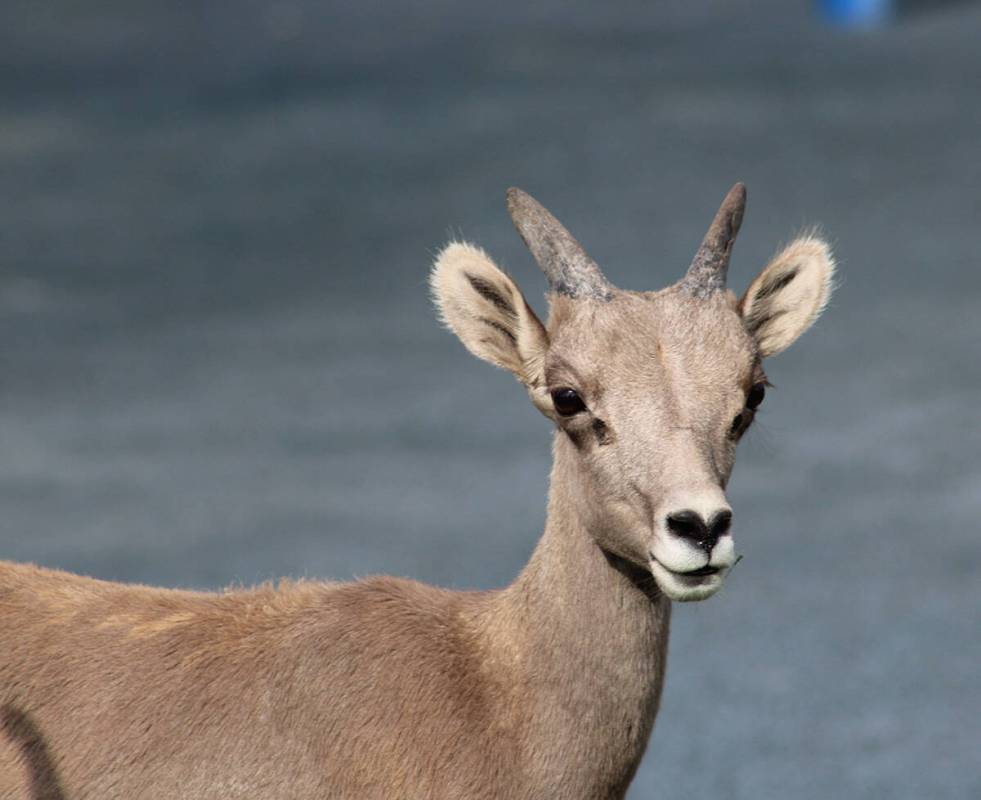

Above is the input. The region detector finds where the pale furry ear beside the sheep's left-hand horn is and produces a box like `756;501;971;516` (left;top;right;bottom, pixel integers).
429;242;548;394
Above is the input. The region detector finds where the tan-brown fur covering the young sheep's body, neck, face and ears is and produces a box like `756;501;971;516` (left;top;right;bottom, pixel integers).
0;188;830;800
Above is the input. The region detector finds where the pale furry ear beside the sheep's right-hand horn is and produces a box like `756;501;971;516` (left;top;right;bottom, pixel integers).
739;236;835;358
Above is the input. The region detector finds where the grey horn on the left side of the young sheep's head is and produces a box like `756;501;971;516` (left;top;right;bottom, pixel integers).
508;188;613;300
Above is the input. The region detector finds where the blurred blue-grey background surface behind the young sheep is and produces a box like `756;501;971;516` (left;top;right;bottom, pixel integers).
0;0;981;800
